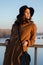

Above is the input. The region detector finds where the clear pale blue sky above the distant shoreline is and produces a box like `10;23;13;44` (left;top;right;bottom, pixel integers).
0;0;43;32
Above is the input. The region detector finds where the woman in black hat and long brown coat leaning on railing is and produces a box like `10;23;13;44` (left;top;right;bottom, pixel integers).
3;5;37;65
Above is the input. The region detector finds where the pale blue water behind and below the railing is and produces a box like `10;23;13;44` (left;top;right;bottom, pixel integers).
0;38;43;65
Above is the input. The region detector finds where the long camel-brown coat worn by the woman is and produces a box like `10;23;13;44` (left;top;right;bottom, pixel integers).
3;22;37;65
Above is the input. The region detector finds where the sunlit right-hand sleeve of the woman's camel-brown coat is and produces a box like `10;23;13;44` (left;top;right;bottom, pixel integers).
28;24;37;46
